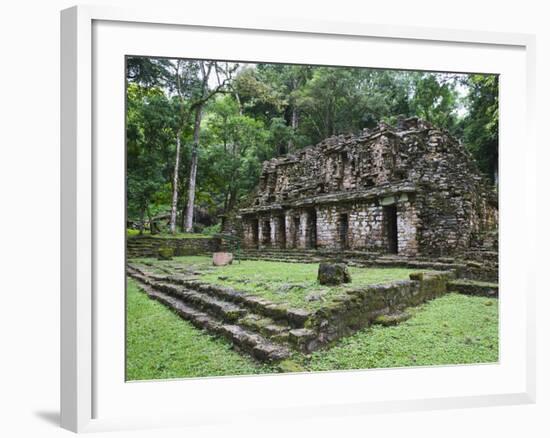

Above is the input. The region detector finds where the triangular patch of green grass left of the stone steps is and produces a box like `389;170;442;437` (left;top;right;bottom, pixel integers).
126;278;275;380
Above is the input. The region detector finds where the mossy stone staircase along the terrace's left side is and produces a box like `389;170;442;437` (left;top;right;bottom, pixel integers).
127;264;314;362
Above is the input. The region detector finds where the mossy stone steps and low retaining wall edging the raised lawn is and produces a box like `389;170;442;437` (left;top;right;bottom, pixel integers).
127;260;498;361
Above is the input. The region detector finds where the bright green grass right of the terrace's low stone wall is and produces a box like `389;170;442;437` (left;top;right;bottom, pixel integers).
306;293;498;371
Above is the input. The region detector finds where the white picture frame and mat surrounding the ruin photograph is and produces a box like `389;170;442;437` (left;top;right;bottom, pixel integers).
61;6;536;432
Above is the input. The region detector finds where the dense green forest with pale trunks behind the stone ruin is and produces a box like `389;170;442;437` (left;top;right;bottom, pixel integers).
126;57;498;233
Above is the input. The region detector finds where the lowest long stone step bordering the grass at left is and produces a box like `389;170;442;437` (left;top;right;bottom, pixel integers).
135;284;290;361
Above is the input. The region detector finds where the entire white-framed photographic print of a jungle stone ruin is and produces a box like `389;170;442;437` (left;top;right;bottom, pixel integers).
61;7;535;431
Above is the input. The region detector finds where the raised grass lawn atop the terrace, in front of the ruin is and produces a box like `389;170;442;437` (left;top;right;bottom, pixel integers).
134;256;418;310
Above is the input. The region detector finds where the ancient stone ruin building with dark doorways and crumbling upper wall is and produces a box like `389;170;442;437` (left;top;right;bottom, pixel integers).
239;118;498;257
